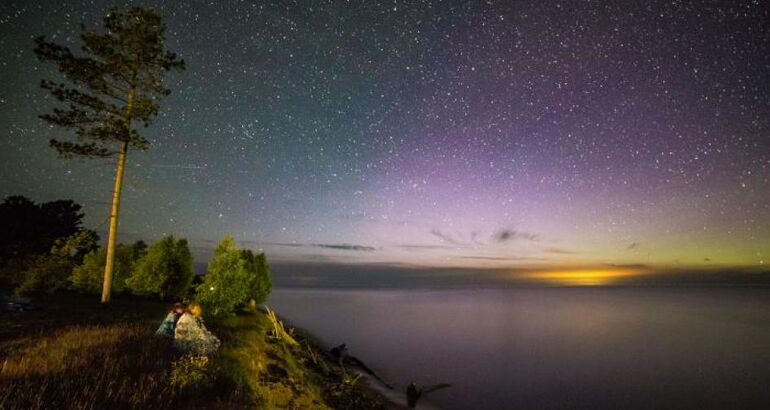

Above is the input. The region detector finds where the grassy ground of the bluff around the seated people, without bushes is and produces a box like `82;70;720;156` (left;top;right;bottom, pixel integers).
0;292;393;409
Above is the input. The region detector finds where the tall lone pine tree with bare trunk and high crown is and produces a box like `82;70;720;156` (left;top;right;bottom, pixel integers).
35;7;184;303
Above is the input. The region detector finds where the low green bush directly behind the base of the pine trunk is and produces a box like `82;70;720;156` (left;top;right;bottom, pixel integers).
70;241;147;294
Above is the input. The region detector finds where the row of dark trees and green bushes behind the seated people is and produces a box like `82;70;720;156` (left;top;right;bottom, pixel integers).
0;196;272;314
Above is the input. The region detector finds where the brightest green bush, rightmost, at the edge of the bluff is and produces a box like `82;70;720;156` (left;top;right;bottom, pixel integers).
197;235;272;315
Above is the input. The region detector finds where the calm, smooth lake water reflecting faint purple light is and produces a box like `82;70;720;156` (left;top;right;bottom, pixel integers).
269;288;770;409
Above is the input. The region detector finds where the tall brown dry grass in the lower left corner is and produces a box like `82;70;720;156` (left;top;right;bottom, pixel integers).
0;324;189;409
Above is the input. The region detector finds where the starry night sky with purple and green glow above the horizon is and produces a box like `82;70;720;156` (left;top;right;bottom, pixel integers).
0;0;770;278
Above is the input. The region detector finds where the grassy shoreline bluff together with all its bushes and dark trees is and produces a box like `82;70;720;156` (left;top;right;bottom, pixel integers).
0;196;396;410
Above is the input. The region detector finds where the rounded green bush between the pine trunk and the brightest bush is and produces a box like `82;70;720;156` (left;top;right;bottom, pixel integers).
126;235;194;299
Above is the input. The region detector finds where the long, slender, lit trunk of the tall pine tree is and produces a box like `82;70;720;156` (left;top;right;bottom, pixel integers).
102;88;134;303
